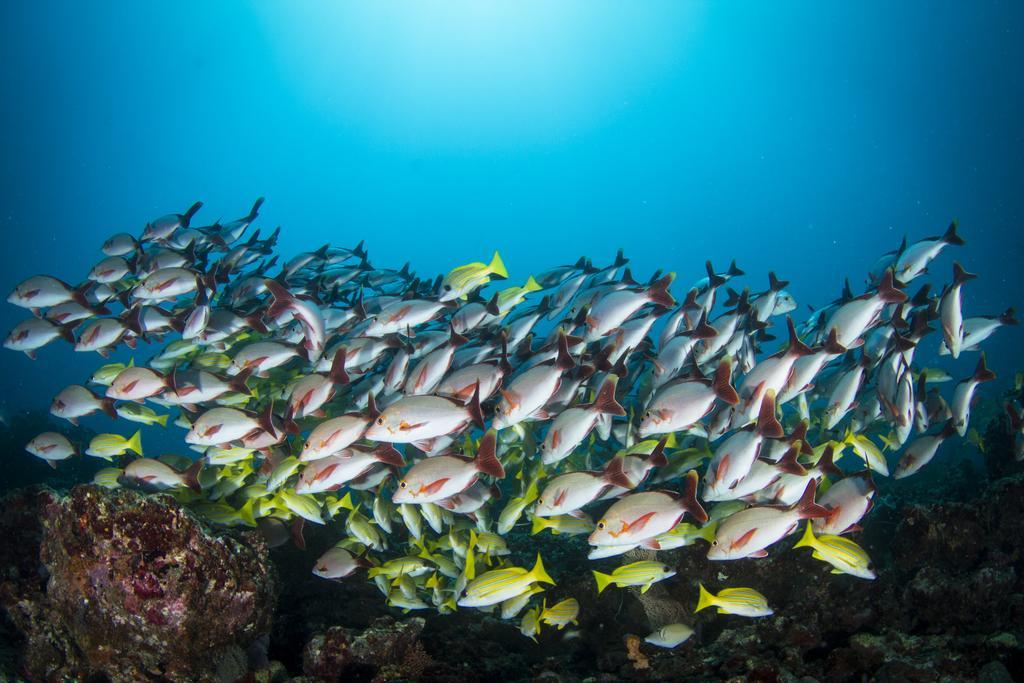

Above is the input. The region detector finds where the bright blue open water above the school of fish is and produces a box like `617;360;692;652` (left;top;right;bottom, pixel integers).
0;0;1024;420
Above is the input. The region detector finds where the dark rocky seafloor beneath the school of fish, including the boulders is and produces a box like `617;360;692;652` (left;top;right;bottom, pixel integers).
0;397;1024;683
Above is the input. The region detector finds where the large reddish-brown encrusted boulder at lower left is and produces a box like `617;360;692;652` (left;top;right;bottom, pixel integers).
0;485;276;681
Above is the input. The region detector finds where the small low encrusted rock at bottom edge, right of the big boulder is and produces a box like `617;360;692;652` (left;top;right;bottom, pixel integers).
302;616;433;683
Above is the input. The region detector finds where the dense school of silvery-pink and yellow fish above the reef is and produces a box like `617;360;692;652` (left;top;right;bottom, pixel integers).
4;198;1024;647
